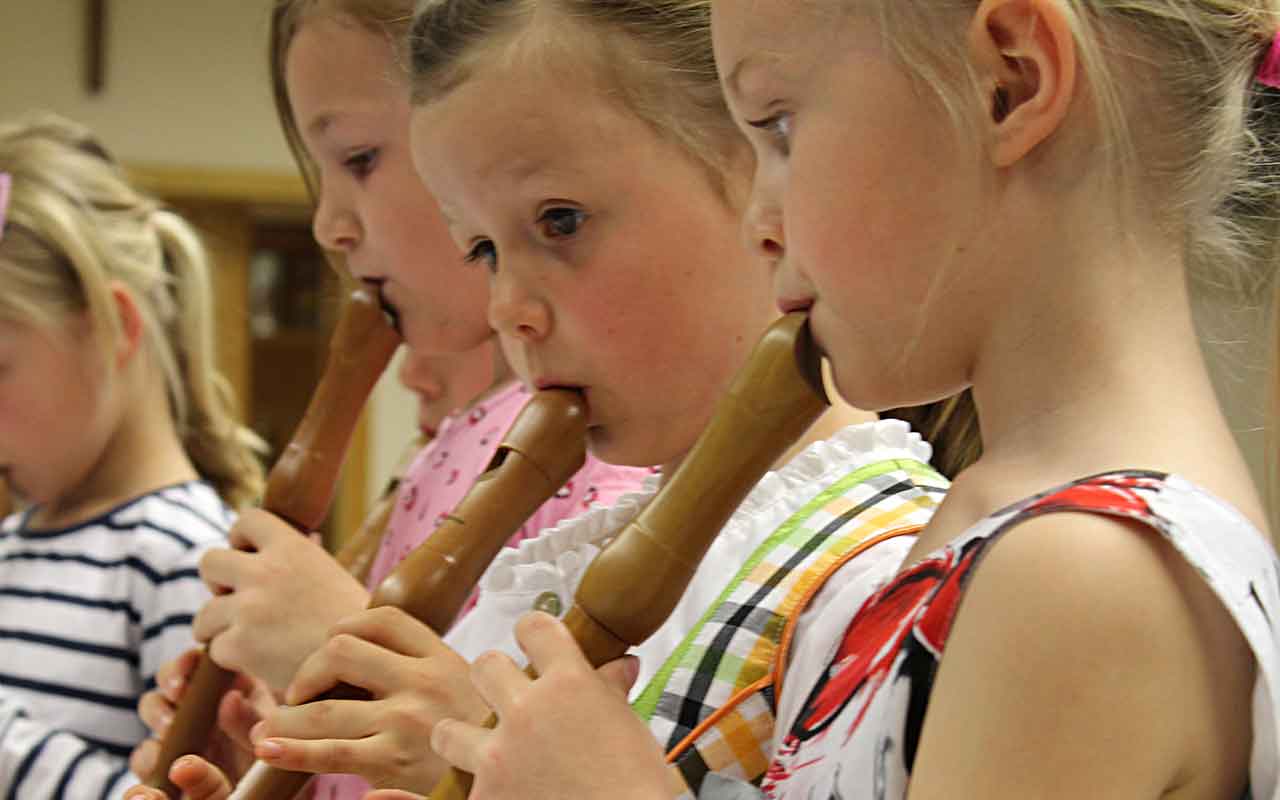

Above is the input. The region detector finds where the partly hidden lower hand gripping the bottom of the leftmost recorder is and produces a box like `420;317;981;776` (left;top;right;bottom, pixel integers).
129;650;276;778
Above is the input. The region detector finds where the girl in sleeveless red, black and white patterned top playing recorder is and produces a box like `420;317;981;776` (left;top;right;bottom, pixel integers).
409;0;1280;800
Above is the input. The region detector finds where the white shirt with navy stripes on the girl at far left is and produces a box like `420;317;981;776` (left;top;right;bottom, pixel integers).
0;483;232;800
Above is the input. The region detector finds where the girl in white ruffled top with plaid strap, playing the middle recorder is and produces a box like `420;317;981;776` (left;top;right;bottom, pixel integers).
122;3;963;797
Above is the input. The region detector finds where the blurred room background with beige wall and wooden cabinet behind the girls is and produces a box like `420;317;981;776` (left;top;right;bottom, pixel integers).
0;0;1280;531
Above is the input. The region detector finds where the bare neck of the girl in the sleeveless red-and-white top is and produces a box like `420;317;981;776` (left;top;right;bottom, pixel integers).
955;198;1265;526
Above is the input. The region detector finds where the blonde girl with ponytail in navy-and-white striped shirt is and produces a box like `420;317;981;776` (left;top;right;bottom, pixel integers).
0;116;262;799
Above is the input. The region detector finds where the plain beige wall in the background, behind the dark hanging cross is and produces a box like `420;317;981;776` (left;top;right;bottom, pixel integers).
0;0;416;497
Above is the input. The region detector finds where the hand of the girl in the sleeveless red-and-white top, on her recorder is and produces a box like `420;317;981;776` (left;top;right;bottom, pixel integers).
431;613;673;800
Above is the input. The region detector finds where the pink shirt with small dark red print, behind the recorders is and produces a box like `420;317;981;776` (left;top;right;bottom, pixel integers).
314;383;650;800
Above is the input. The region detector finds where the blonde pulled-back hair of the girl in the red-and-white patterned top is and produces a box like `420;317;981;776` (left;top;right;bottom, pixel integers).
838;0;1280;499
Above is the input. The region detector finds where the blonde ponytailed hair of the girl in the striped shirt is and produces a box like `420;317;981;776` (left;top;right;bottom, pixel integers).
0;115;262;506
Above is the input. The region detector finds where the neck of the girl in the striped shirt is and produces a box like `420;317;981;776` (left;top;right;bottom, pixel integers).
32;358;198;527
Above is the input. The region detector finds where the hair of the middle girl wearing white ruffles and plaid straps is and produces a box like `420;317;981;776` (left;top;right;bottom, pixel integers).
408;0;982;477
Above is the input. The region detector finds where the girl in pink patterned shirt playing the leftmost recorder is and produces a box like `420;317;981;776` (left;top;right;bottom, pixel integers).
126;0;649;796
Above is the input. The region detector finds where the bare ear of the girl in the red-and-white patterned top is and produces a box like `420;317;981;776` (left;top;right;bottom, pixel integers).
968;0;1078;166
